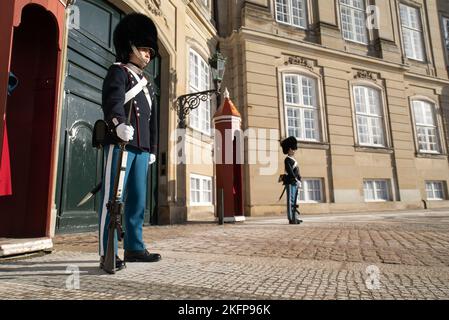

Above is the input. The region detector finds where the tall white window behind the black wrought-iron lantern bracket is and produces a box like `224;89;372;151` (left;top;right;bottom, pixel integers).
189;49;211;135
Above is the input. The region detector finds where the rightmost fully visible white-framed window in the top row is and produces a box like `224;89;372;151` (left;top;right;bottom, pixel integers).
399;3;426;62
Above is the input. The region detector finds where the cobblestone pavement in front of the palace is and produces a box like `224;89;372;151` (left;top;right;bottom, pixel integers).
0;210;449;299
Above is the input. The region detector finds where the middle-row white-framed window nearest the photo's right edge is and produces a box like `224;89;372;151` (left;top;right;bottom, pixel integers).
411;99;441;154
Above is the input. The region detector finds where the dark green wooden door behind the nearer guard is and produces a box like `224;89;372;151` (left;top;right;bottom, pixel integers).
56;0;158;232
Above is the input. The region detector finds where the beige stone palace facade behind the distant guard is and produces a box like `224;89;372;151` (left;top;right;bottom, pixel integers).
218;0;449;216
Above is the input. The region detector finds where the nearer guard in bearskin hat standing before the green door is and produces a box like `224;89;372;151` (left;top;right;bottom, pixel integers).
99;13;161;270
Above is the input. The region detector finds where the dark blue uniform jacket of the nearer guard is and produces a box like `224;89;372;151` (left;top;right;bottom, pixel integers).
102;65;158;154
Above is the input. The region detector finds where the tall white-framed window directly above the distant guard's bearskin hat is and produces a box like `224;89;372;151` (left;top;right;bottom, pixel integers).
282;73;321;142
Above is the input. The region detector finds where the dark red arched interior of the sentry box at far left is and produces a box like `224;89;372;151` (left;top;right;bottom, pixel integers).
0;4;59;238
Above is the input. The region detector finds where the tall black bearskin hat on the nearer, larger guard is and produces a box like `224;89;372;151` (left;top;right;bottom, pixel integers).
114;13;158;63
